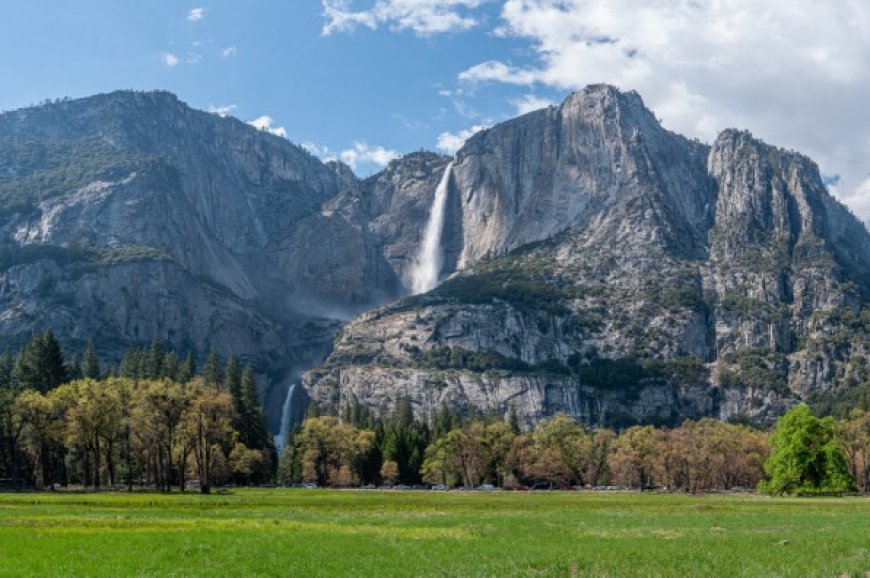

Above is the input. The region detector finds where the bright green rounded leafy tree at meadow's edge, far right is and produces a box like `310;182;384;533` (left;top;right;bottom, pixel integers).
759;405;855;495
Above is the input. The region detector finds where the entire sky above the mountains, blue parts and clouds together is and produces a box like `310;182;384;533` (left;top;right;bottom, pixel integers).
0;0;870;221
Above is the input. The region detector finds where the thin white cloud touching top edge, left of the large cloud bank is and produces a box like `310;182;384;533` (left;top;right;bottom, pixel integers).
322;0;485;36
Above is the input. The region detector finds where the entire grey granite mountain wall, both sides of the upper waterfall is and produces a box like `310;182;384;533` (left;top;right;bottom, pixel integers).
0;85;870;430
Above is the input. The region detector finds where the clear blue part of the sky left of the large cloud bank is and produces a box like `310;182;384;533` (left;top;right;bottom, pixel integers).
0;0;567;174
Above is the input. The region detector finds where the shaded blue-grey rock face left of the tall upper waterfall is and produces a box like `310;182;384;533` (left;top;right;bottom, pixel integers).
0;92;447;422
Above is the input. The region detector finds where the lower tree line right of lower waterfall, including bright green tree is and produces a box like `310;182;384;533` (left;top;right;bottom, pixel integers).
278;400;870;494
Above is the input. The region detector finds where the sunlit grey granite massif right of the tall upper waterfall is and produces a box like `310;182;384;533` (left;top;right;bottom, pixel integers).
303;86;870;425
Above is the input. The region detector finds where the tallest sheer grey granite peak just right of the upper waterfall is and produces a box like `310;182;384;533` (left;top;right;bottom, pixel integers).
454;85;715;265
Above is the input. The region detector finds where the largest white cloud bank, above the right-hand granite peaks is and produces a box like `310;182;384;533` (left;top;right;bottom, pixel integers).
459;0;870;219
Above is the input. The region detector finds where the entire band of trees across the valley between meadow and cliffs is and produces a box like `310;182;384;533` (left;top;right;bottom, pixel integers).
0;331;870;494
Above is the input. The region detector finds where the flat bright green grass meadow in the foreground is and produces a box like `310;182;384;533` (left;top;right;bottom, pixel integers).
0;490;870;577
